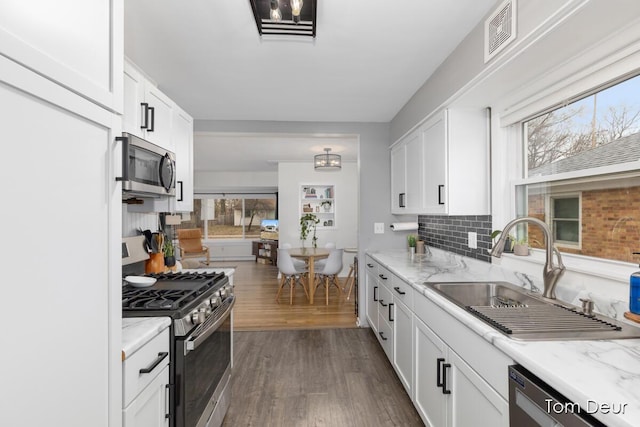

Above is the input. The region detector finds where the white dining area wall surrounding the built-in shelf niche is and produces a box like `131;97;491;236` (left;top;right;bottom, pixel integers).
278;162;359;276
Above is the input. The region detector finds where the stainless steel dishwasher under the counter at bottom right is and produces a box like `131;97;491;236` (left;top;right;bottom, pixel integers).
509;365;605;427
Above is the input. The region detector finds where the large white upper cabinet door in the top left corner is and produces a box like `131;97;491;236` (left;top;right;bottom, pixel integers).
0;0;124;113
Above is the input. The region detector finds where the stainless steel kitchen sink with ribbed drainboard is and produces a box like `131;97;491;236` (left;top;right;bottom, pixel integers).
424;282;640;341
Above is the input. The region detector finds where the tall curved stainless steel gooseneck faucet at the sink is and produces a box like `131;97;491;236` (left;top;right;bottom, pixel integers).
491;216;565;299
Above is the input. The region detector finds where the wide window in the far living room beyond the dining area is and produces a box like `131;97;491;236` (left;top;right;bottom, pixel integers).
180;194;277;239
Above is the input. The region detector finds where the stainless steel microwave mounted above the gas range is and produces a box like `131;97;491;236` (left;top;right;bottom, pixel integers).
116;132;176;197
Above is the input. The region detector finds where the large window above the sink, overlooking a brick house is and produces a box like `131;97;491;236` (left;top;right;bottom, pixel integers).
516;72;640;262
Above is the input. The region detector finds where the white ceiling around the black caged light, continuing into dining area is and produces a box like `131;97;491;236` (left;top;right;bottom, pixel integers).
124;0;495;170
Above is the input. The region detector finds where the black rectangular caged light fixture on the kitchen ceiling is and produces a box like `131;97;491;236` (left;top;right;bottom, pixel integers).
249;0;317;38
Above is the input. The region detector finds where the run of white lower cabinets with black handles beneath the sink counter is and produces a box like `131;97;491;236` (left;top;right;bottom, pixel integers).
366;256;514;427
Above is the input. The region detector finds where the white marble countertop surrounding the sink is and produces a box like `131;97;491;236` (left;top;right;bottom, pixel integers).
367;248;640;427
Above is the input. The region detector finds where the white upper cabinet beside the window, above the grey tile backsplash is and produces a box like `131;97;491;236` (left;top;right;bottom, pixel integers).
391;109;490;215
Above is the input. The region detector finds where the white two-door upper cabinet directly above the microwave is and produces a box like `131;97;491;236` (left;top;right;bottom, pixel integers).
123;61;175;152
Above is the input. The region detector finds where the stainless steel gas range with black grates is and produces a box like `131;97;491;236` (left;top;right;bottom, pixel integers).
122;237;235;427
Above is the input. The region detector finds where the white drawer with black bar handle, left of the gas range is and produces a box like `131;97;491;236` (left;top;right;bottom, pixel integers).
122;328;169;407
